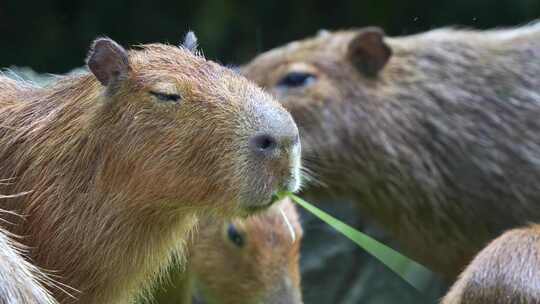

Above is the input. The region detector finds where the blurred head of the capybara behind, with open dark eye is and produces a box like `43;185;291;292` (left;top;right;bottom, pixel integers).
242;28;392;182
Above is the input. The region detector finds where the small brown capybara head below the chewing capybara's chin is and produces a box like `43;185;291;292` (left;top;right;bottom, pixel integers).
189;199;302;304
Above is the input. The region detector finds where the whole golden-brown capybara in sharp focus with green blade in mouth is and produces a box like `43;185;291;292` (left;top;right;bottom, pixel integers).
0;32;300;303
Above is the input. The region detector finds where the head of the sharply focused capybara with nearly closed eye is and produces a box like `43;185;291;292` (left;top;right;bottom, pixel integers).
81;33;300;215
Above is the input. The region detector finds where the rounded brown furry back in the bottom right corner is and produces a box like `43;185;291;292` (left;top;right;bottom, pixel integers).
442;224;540;304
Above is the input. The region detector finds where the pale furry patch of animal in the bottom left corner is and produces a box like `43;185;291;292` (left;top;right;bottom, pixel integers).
0;195;56;304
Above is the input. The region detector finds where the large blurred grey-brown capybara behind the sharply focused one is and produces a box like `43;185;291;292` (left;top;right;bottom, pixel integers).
243;24;540;280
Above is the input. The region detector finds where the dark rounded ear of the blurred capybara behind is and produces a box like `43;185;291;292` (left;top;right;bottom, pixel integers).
347;27;392;77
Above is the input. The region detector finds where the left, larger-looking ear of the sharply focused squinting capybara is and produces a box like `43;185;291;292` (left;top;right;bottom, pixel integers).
86;38;130;87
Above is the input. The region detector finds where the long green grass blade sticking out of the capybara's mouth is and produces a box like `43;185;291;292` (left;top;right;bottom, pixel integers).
281;193;433;292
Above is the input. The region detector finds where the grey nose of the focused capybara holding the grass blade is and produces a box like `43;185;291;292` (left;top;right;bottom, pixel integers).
249;128;299;158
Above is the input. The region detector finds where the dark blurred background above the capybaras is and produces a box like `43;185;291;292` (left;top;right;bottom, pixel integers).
0;0;540;73
